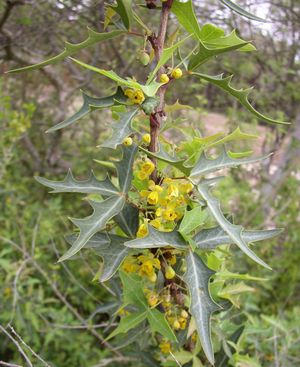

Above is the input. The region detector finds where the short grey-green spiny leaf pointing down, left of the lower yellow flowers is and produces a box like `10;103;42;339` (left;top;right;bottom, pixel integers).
95;234;130;282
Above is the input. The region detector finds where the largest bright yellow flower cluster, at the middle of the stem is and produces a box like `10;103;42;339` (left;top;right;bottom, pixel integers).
137;178;193;230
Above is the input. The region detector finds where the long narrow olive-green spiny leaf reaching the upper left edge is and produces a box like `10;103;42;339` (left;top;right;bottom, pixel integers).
9;28;125;73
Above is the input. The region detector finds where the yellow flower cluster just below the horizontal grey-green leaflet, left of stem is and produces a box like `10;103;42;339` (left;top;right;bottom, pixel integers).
122;251;161;283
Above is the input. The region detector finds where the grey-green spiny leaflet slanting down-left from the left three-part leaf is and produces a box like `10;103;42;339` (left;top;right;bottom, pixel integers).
59;196;125;262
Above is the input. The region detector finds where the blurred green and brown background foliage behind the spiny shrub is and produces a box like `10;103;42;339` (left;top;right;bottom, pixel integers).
0;0;300;367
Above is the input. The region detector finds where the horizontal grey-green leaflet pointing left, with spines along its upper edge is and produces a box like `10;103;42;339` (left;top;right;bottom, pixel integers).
35;170;119;196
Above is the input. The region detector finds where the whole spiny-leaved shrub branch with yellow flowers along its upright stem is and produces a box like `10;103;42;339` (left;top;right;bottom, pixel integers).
11;0;284;366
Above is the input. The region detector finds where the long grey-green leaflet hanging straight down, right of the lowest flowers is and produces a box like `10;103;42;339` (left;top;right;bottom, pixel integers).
184;250;219;364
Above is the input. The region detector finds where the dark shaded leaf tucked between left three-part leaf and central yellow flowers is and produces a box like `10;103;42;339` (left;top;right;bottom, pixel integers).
114;203;139;238
